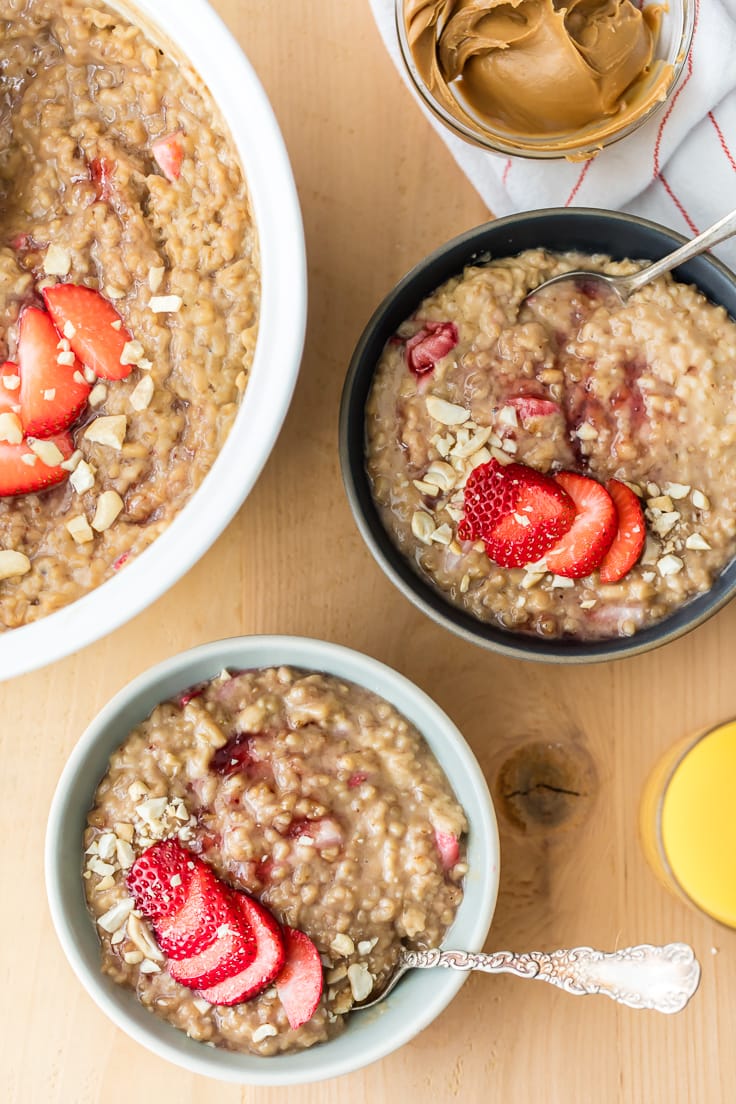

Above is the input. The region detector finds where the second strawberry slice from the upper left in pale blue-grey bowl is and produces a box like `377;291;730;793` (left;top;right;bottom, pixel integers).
153;856;233;959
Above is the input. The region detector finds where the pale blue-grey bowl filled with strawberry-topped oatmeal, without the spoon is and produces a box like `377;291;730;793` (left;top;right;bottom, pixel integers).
46;637;499;1084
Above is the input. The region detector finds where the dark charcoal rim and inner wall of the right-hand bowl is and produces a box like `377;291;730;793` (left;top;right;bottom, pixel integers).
339;206;736;664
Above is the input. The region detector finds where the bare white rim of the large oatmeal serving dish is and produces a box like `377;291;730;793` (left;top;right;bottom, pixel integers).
0;0;307;680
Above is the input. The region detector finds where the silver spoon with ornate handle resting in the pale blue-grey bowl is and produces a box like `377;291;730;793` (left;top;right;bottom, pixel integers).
352;943;701;1012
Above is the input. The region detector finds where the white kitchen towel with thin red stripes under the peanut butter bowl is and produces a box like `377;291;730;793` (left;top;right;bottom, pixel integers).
371;0;736;268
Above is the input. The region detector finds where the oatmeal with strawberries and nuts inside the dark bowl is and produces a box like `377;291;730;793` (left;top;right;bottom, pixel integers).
366;250;736;638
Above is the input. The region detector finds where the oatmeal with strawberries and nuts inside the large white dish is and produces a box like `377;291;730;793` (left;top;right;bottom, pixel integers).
0;0;259;629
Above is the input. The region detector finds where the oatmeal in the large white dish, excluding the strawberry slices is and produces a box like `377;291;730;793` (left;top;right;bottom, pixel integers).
0;0;259;629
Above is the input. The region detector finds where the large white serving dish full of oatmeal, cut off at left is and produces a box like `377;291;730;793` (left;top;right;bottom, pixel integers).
0;0;306;678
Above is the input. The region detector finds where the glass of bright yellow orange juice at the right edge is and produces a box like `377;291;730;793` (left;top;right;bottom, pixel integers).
641;720;736;928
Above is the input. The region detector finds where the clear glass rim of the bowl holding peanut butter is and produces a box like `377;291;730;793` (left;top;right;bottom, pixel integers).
393;0;696;161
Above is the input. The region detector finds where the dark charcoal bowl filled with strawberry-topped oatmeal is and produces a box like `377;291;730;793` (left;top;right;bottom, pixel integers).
340;210;736;661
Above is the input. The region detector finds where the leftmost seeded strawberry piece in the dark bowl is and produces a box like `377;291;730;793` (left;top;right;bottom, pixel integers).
458;460;575;567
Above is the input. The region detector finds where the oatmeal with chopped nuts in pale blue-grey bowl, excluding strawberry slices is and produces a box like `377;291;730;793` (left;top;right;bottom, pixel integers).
84;668;467;1054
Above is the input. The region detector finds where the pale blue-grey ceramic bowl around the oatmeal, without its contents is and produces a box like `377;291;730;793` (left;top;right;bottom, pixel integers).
45;636;499;1085
